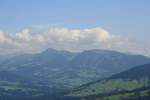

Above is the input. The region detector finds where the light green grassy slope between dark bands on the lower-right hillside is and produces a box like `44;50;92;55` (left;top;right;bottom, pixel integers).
68;78;149;97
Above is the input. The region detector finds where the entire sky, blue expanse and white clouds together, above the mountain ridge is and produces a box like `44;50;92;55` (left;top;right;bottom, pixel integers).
0;0;150;54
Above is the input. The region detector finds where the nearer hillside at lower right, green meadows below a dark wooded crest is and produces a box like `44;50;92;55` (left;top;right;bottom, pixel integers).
66;63;150;100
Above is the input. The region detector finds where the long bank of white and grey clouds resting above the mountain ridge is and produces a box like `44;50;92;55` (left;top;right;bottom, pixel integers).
0;27;150;54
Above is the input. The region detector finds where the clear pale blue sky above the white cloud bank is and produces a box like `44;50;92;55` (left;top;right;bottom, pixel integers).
0;0;150;40
